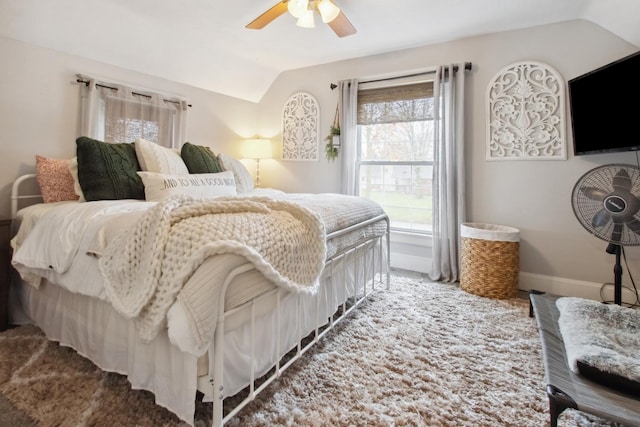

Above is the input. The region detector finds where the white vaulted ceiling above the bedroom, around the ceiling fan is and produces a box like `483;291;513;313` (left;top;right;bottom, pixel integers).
0;0;640;102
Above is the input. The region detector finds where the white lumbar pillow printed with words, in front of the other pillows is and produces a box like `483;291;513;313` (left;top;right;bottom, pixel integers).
138;171;238;202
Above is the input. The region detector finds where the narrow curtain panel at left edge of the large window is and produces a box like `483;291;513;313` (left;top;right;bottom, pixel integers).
338;79;358;195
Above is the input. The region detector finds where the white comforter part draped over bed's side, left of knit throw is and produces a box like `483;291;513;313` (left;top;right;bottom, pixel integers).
11;200;155;299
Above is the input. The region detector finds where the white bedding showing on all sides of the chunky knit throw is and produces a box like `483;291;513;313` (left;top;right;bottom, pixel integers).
11;191;385;355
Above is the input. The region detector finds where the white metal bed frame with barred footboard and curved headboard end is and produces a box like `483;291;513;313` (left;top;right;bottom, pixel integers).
11;174;390;426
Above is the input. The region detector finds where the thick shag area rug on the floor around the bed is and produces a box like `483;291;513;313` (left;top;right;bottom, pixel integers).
0;271;624;427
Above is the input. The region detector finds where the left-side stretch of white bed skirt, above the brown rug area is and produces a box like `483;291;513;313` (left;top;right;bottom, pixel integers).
12;282;198;424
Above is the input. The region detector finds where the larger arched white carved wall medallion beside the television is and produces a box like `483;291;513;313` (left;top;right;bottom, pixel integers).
487;61;567;160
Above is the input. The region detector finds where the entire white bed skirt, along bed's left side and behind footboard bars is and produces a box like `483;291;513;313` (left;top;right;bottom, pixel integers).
10;241;388;424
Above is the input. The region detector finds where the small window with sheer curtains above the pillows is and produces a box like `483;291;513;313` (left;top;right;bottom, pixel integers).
80;78;187;147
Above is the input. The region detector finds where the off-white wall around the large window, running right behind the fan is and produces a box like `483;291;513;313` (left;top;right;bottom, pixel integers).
258;21;640;297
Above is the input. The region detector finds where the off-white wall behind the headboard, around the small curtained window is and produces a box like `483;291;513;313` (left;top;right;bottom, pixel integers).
0;37;257;218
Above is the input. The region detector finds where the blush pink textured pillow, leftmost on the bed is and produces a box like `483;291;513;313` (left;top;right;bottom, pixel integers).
36;155;78;203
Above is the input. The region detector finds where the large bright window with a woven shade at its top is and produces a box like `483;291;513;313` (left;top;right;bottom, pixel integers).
356;82;434;234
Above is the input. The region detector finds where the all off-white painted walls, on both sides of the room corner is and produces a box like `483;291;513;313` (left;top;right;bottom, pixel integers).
0;21;640;296
